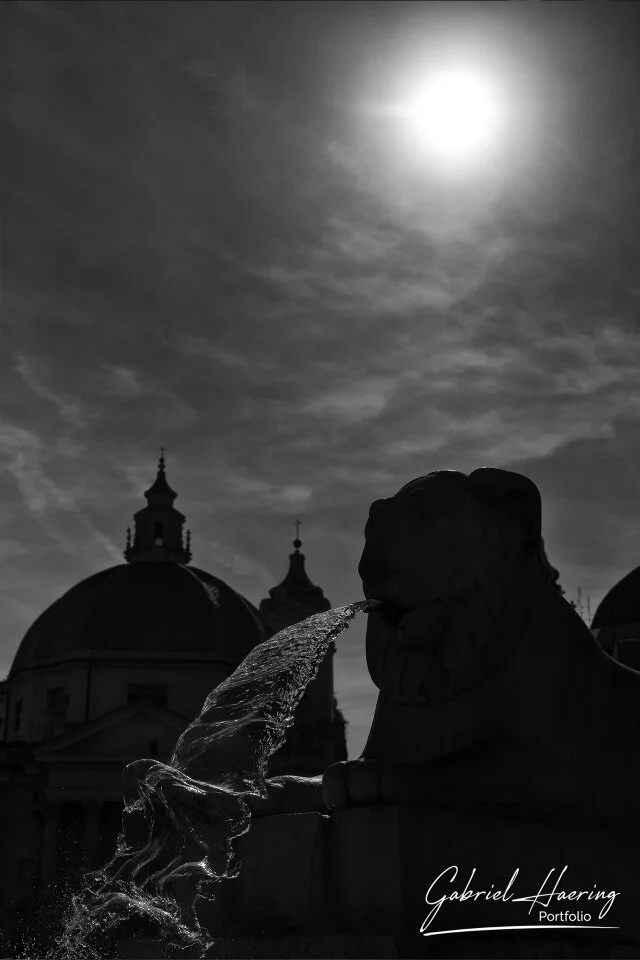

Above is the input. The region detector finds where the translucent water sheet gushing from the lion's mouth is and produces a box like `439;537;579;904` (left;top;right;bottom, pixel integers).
48;600;379;960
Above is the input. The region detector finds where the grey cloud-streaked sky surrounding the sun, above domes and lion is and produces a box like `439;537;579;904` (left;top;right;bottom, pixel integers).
0;0;640;755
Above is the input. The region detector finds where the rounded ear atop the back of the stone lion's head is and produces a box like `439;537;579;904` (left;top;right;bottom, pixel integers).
469;467;542;557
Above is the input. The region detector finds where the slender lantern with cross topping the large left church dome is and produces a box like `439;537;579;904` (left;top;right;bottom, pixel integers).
124;447;191;563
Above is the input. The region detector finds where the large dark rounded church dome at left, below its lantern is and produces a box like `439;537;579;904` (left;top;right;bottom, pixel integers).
9;562;272;678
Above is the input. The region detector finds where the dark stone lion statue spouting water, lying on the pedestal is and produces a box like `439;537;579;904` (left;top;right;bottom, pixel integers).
323;468;640;826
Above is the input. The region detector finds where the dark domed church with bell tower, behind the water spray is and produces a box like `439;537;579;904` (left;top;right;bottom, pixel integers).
0;456;346;952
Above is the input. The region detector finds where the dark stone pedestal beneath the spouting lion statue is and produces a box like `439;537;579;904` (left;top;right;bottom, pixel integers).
117;806;640;958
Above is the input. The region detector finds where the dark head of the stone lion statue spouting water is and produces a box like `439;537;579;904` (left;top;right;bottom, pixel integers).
358;468;544;703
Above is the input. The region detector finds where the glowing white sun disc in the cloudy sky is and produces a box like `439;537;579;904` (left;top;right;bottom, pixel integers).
406;67;505;167
